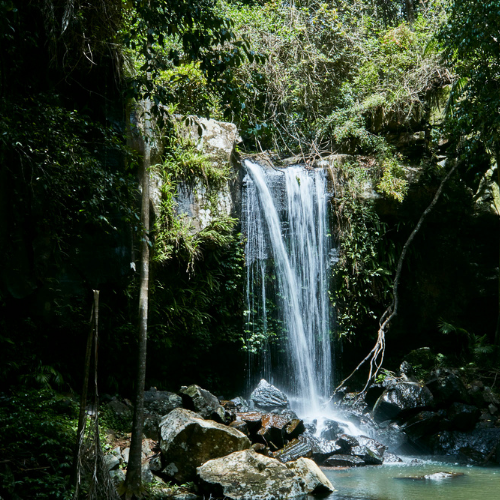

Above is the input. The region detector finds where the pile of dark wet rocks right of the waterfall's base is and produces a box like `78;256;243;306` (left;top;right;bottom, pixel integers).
337;352;500;463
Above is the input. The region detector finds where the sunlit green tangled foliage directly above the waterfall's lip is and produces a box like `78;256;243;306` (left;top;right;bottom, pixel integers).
222;0;450;156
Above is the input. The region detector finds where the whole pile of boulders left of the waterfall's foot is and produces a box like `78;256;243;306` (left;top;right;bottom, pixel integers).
106;381;340;500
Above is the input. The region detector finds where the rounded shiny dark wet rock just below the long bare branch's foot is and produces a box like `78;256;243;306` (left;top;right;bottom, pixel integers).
373;382;434;422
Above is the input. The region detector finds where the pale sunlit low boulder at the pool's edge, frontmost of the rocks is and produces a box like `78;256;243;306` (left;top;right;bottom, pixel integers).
197;450;334;500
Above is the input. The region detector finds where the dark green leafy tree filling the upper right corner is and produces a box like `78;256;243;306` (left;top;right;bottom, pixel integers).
438;0;500;347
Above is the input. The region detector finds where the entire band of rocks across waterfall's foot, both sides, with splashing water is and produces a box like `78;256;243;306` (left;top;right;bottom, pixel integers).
100;362;500;500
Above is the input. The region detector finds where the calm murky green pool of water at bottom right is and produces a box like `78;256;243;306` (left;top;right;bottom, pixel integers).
323;462;500;500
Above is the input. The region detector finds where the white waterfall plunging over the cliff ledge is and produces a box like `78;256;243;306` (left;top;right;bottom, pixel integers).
242;160;332;413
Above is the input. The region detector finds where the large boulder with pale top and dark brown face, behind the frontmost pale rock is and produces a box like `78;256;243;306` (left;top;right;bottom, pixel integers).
160;408;251;483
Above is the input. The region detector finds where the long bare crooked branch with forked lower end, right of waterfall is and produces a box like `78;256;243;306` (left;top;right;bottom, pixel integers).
329;162;458;402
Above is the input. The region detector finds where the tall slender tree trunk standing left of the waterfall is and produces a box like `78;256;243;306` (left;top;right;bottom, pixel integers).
124;103;151;499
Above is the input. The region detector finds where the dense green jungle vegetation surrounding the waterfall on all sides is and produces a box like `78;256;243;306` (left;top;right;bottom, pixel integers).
0;0;500;499
